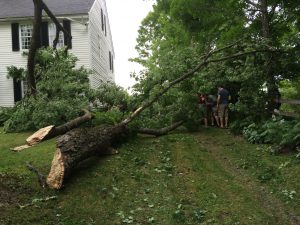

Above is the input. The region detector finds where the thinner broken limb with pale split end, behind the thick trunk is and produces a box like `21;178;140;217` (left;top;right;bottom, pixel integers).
12;109;92;151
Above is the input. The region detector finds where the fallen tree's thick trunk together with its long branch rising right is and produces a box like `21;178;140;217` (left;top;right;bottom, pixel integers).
47;42;276;189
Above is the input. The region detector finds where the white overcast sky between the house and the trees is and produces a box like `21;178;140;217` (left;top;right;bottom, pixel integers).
106;0;153;88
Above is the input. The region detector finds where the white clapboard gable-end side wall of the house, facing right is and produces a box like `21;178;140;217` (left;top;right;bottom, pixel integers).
89;0;114;88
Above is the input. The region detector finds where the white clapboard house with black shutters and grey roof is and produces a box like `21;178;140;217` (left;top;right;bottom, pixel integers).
0;0;114;106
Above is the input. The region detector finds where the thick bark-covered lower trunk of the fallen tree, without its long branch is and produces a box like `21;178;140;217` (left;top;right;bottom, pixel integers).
47;125;129;189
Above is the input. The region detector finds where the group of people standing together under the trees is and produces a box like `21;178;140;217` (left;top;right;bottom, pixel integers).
198;85;231;128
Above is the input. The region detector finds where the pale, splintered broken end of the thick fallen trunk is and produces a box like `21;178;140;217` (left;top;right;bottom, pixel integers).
47;148;65;189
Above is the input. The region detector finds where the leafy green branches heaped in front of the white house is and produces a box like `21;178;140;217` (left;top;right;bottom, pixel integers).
4;48;91;132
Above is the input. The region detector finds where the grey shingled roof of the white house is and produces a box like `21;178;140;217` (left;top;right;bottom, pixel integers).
0;0;95;19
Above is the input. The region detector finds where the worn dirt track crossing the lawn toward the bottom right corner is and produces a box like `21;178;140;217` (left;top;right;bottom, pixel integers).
196;131;300;225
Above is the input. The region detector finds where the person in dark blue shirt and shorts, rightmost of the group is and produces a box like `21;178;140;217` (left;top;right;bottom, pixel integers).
217;85;231;128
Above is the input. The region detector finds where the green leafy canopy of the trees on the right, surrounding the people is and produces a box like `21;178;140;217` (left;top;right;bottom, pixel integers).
132;0;300;139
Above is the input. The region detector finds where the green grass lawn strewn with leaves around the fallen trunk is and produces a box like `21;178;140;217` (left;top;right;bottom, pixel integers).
0;128;300;225
